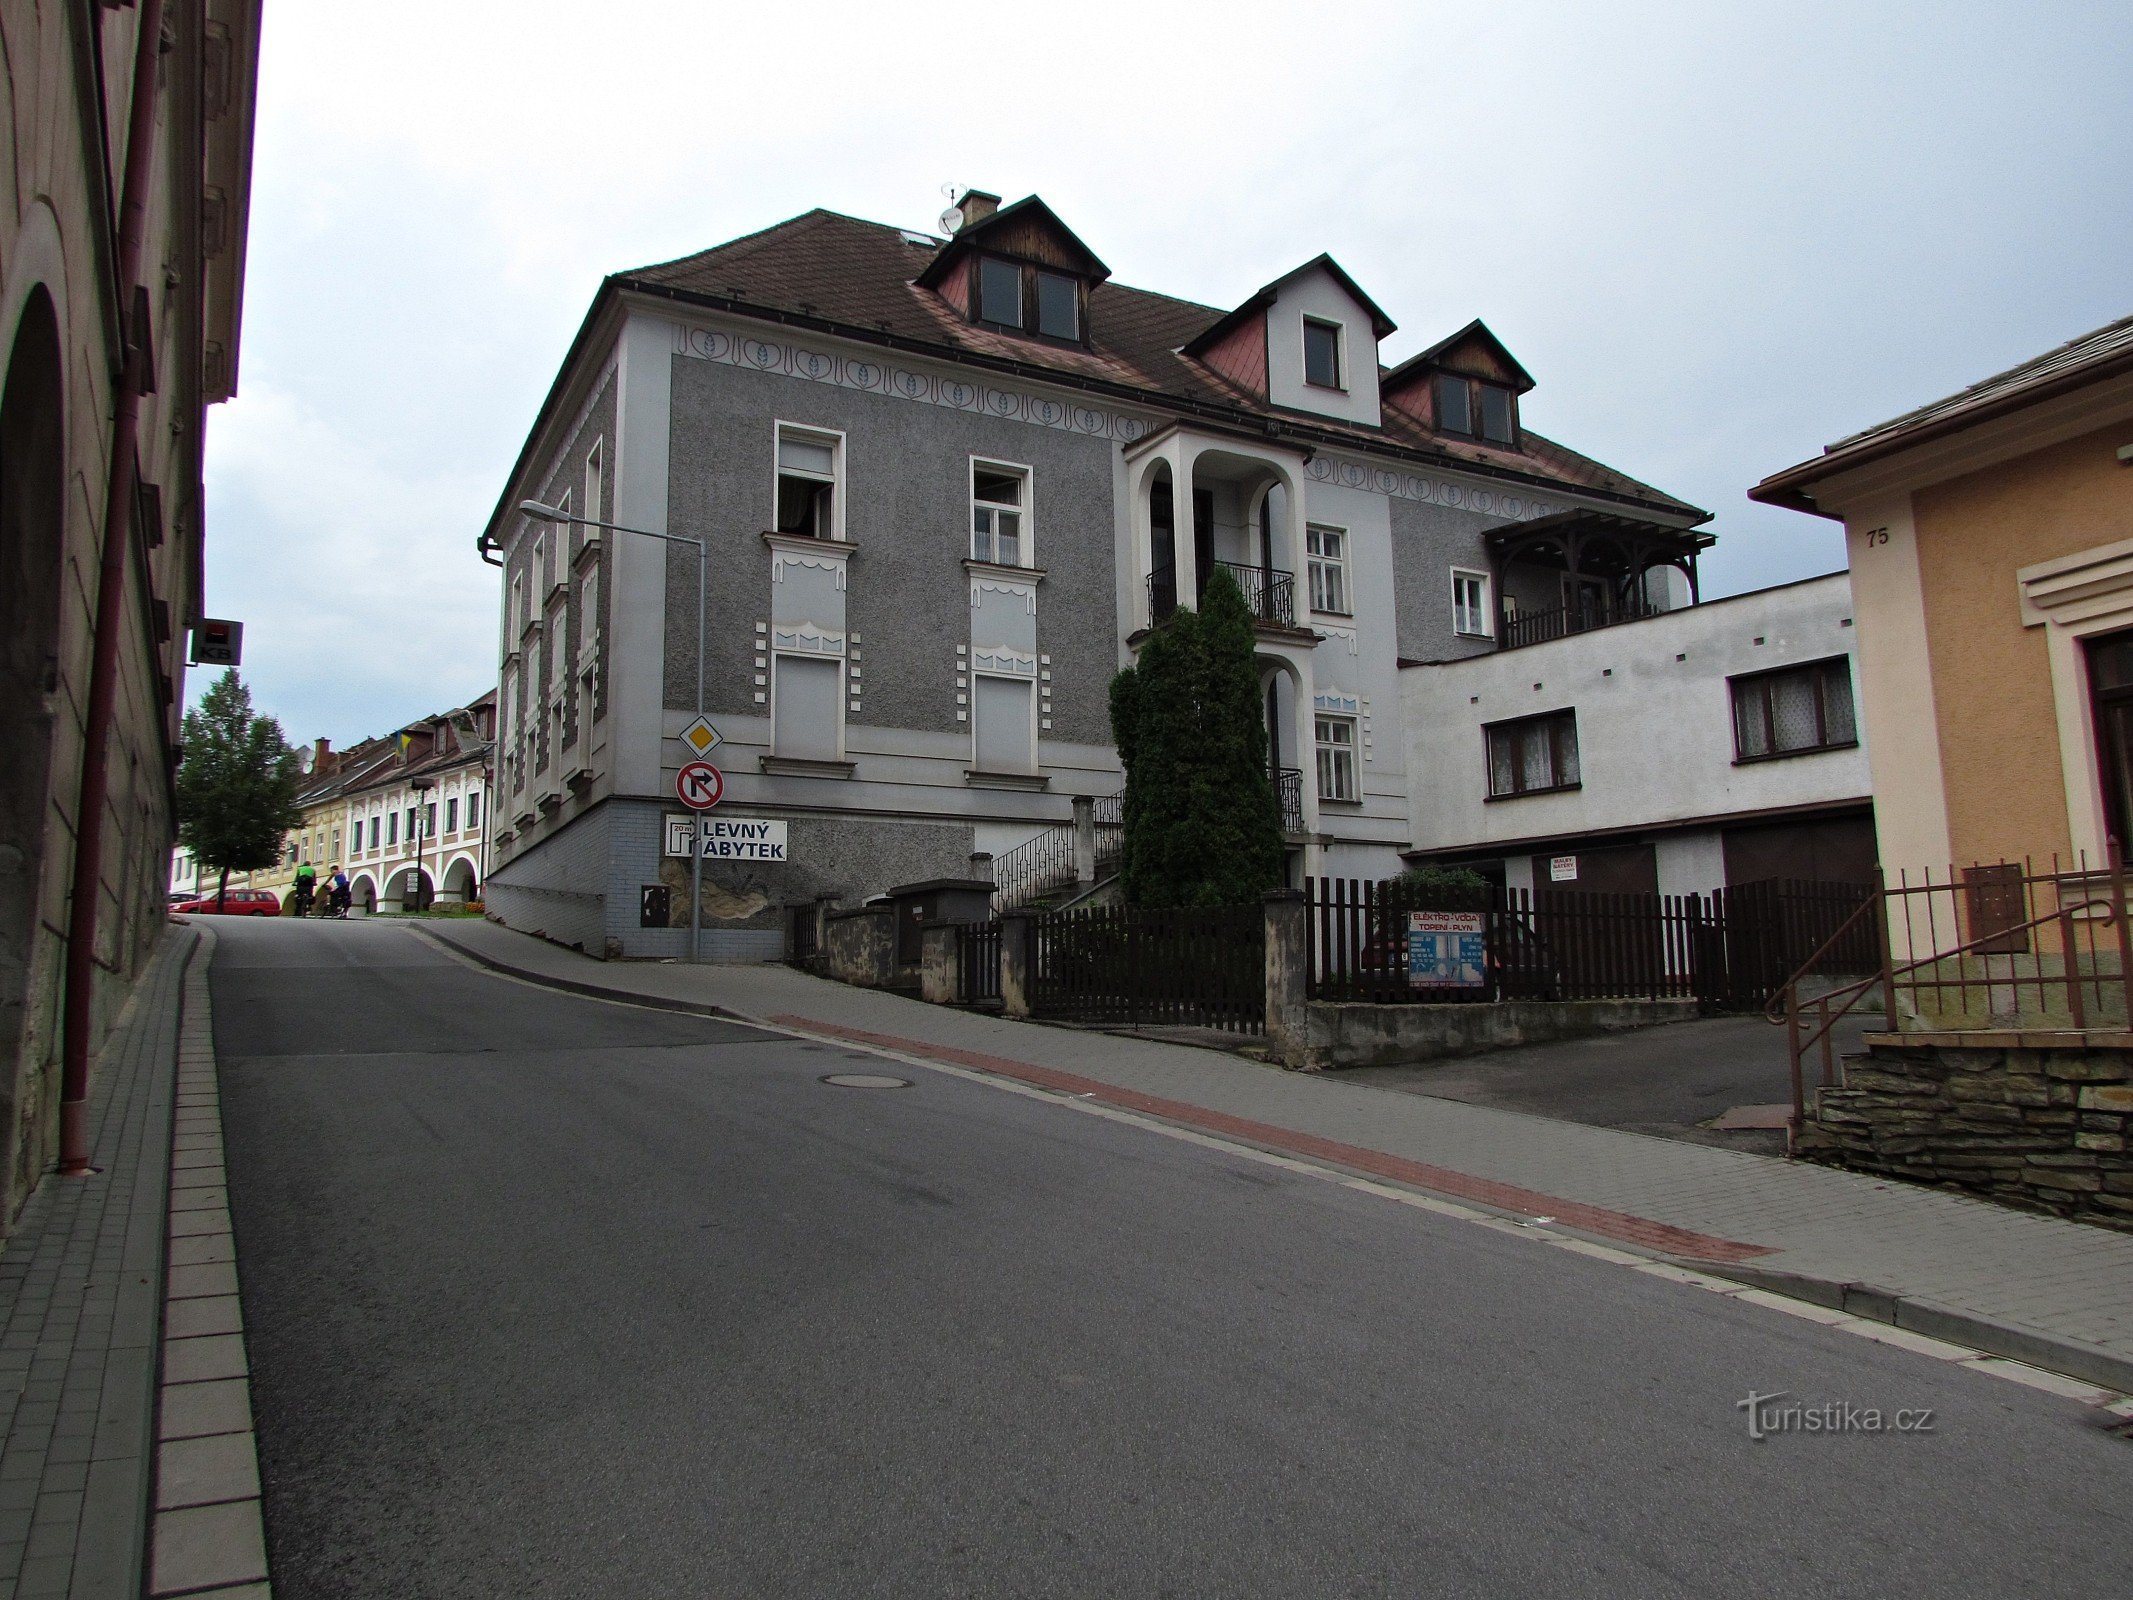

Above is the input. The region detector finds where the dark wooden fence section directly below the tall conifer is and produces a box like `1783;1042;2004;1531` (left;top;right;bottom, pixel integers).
1030;905;1267;1033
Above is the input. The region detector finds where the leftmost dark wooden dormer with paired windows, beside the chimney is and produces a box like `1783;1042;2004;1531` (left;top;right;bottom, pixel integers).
915;190;1111;346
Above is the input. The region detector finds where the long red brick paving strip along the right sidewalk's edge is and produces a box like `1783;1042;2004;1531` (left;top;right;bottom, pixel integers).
770;1015;1773;1261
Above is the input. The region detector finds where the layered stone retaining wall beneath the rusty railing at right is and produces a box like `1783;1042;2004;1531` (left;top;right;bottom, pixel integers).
1796;1033;2133;1231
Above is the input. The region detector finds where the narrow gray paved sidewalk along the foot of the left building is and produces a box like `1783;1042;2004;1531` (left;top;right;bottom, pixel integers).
0;926;196;1600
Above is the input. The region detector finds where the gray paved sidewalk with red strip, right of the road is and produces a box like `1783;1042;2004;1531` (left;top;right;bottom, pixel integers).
422;919;2133;1389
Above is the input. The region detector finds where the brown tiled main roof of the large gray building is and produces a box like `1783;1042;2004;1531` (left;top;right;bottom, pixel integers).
614;209;1704;518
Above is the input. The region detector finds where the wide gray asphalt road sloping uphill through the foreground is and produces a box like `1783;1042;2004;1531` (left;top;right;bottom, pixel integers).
211;922;2133;1600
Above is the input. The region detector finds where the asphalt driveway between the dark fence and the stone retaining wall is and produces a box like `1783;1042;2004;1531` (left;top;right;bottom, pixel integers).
1342;1015;1879;1156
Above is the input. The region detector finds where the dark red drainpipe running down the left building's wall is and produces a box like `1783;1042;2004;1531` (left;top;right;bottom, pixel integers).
60;0;162;1178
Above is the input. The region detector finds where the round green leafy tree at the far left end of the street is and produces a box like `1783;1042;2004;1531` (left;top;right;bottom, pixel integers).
177;670;303;907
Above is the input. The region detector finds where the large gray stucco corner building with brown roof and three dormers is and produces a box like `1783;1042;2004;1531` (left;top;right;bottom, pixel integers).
482;192;1709;958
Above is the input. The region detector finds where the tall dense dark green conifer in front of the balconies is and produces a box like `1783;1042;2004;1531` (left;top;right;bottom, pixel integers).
1111;567;1284;907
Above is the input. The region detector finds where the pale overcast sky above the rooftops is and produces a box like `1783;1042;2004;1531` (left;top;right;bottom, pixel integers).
190;0;2133;745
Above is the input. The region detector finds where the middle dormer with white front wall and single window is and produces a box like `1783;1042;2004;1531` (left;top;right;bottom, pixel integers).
1184;256;1393;427
